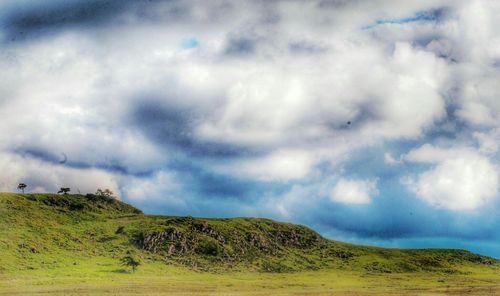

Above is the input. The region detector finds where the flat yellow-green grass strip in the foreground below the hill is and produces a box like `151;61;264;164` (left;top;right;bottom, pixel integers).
0;258;500;295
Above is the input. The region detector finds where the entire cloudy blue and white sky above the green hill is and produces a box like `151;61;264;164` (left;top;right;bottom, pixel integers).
0;0;500;258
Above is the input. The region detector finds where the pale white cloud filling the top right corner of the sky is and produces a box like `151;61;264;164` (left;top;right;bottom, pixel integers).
450;1;500;127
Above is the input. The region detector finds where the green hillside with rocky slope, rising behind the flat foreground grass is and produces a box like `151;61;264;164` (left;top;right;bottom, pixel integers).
0;193;500;294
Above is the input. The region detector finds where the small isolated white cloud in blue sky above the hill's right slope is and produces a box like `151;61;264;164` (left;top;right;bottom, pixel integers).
330;178;378;204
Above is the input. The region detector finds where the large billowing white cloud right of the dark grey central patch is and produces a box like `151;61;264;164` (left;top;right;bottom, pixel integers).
197;40;447;150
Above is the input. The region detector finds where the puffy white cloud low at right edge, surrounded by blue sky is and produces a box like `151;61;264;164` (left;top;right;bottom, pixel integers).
403;145;500;211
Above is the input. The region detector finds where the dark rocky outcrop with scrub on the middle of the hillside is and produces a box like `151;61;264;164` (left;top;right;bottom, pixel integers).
133;217;327;265
